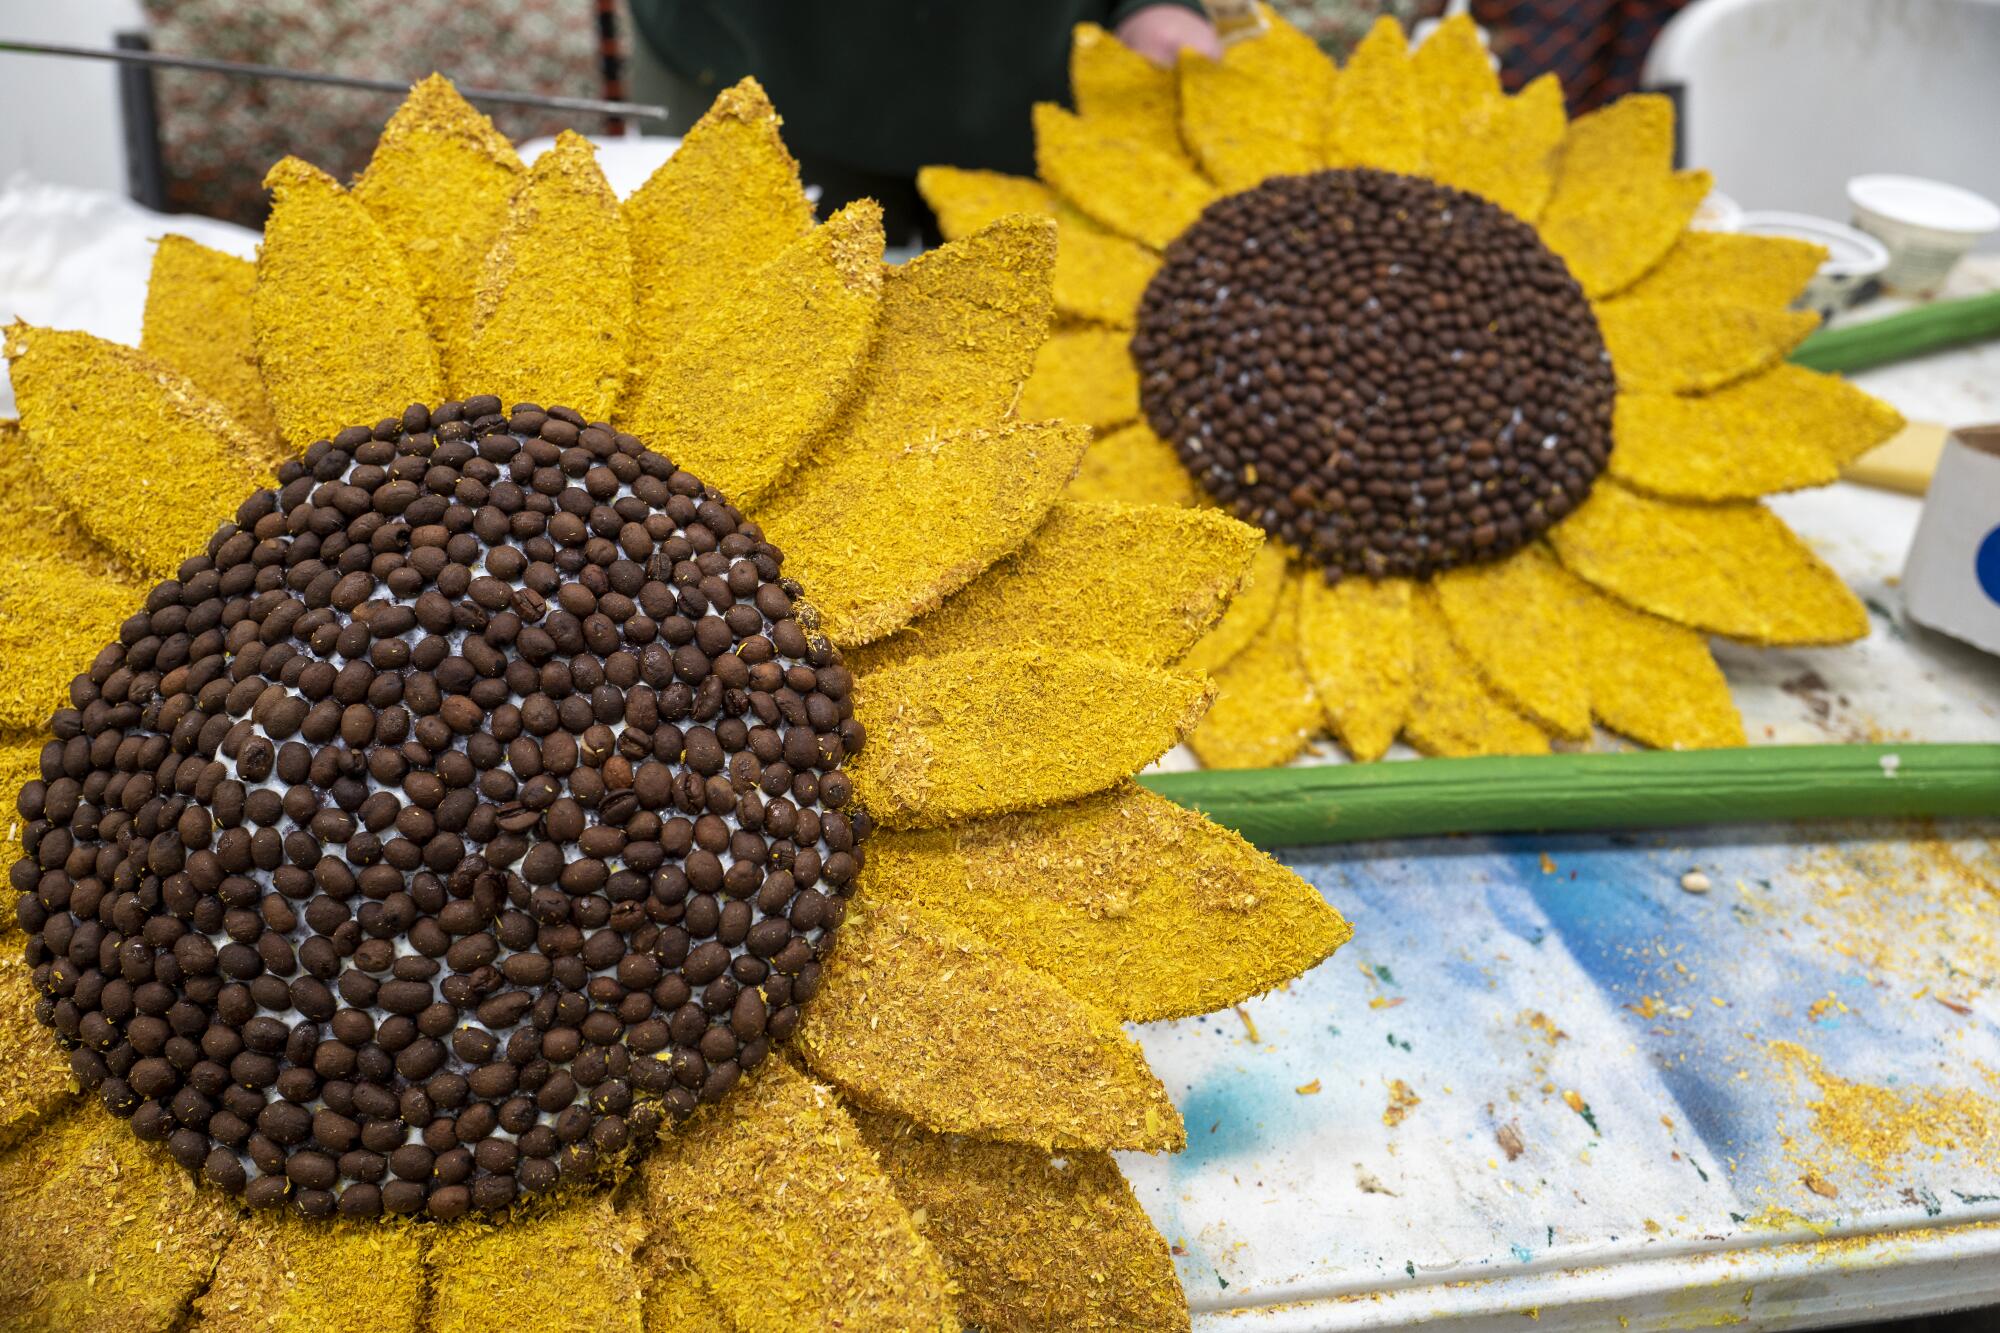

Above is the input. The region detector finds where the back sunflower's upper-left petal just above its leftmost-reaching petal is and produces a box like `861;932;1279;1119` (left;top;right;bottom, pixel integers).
1034;102;1216;250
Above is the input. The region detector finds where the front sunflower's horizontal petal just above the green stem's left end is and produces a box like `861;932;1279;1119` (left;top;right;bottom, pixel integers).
850;644;1210;829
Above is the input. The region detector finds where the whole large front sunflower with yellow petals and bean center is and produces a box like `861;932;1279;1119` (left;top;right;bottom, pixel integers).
0;78;1346;1333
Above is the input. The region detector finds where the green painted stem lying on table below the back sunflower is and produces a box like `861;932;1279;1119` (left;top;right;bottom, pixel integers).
1140;745;2000;847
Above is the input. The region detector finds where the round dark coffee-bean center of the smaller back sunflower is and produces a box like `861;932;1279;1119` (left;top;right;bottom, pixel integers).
1132;170;1614;578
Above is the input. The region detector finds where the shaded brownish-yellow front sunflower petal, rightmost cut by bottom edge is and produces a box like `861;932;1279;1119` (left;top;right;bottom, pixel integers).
856;1111;1188;1333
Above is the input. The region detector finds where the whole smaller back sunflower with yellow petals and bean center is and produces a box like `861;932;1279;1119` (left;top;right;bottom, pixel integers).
922;12;1898;767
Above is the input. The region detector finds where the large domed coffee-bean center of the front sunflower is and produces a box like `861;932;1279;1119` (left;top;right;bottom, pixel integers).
12;396;868;1219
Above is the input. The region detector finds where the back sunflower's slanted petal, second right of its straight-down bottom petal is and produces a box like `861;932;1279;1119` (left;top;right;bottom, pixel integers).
1434;546;1590;741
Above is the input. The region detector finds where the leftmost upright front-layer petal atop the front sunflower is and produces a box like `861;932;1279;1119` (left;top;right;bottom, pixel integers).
250;158;444;450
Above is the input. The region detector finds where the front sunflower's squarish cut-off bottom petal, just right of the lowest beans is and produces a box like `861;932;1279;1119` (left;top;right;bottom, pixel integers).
424;1195;646;1333
